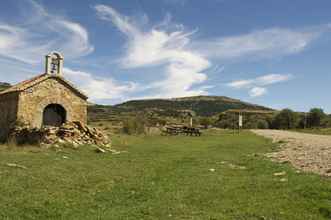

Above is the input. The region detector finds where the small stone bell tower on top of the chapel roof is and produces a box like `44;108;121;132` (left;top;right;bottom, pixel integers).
45;52;63;76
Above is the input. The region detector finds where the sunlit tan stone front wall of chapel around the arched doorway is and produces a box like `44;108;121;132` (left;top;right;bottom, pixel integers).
17;78;87;128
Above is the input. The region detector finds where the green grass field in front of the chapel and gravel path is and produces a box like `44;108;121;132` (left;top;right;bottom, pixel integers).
0;132;331;220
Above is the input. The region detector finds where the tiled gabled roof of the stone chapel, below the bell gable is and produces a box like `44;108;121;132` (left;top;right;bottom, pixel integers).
0;73;88;99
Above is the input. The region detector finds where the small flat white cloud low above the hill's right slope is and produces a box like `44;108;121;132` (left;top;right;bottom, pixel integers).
227;74;292;97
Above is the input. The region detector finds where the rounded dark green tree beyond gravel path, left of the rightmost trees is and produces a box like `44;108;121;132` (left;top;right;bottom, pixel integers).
272;109;298;129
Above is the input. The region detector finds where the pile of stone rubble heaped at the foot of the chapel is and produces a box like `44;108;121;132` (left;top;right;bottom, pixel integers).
10;122;111;152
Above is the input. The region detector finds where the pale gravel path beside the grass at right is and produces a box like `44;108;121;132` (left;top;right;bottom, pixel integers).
252;130;331;176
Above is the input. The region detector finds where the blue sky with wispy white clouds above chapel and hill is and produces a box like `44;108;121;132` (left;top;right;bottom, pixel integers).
0;0;331;113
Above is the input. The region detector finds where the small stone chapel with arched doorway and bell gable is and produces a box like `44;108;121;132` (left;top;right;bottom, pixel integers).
0;52;88;141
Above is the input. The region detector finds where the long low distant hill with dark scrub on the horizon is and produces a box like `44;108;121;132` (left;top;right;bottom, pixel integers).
88;96;272;121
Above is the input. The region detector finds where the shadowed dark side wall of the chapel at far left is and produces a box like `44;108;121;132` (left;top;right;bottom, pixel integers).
0;93;18;142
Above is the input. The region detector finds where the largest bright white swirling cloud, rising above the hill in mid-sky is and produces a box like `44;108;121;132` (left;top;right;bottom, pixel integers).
95;5;211;97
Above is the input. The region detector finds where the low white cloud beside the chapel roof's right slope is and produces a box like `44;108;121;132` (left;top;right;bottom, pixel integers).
63;68;137;102
